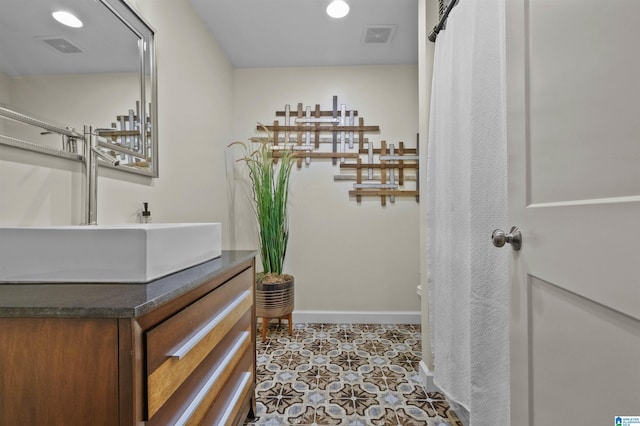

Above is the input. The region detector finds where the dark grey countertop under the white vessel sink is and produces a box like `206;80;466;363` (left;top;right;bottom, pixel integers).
0;250;256;318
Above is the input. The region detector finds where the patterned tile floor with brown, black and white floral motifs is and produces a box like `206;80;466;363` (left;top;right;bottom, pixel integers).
249;322;462;426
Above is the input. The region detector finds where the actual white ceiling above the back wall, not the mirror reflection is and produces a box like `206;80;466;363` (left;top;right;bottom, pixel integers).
191;0;418;68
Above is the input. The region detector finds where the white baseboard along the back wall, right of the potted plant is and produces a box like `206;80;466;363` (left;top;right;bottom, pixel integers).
293;311;421;324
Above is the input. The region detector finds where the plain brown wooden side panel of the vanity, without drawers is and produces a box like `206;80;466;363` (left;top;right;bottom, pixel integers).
0;318;121;426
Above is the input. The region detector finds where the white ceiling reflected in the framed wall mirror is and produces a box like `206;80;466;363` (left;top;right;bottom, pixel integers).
0;0;140;75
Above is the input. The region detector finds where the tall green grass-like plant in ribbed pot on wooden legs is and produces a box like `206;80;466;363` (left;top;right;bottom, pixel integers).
229;126;296;341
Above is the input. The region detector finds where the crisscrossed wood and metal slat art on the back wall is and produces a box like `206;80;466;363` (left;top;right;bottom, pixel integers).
257;96;419;206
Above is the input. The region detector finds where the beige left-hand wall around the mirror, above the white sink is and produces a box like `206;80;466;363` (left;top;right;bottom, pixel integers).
0;0;233;248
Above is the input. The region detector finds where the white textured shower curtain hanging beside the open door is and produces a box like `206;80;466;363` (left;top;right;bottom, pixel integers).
427;0;510;426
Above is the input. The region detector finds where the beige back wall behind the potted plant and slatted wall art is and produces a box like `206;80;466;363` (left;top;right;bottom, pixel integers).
232;65;420;312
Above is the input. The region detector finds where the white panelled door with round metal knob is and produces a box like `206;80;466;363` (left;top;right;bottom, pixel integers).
500;0;640;426
